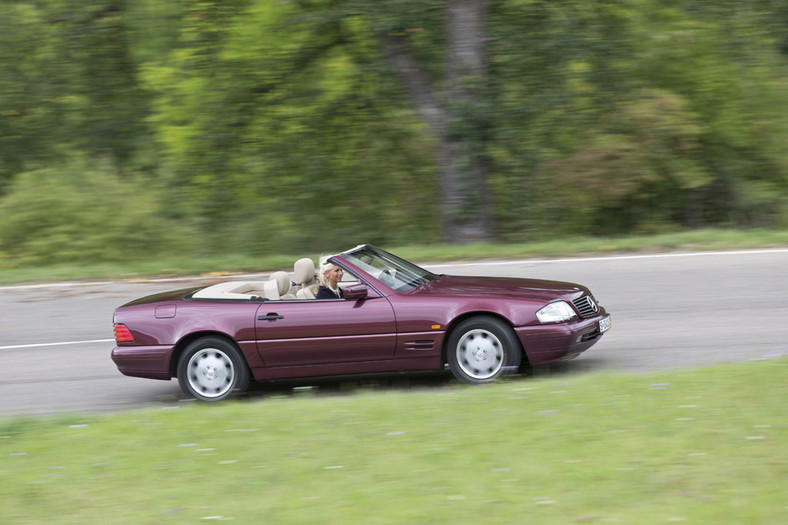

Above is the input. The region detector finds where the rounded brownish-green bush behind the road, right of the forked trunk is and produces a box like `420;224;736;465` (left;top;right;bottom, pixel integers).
544;90;711;232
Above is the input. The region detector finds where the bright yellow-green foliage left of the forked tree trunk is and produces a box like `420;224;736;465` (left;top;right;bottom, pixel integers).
144;2;435;253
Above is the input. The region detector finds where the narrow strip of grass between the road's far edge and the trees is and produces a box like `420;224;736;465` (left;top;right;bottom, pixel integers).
0;225;788;284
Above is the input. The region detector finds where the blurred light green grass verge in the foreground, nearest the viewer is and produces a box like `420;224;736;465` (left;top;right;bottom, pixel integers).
0;360;788;525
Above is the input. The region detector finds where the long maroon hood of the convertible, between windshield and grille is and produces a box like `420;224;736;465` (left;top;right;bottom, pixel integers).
412;275;588;302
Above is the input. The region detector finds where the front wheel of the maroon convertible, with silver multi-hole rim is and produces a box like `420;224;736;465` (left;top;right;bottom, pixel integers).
446;316;523;383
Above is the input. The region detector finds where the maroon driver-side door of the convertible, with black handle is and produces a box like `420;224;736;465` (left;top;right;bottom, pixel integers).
255;289;397;367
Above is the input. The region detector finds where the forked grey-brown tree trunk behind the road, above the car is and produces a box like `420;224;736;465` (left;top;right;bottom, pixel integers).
384;0;492;243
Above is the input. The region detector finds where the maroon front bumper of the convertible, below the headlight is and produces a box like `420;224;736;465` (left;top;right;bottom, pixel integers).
515;313;607;366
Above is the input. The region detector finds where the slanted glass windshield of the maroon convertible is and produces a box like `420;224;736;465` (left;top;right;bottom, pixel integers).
341;246;437;292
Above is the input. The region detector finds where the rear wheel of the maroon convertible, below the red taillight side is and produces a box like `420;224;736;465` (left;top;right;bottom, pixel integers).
178;337;250;401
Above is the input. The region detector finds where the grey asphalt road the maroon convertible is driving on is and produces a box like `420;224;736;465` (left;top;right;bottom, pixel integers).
0;249;788;417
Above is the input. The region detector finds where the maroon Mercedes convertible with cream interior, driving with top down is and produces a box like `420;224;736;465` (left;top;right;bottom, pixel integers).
112;244;610;401
